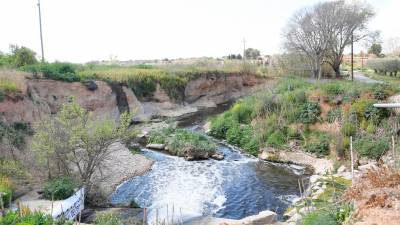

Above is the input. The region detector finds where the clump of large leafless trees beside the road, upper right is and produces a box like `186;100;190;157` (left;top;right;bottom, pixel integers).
285;0;374;79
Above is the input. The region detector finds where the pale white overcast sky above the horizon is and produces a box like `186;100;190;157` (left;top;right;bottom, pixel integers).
0;0;400;62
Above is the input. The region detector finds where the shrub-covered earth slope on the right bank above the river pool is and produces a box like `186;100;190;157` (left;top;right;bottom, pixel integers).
210;78;396;159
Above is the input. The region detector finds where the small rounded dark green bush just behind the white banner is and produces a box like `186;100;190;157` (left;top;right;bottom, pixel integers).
43;177;76;200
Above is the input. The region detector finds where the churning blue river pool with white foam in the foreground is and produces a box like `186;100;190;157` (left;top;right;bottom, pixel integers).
112;129;307;223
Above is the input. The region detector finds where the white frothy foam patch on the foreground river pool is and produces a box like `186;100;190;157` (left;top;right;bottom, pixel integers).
127;150;226;223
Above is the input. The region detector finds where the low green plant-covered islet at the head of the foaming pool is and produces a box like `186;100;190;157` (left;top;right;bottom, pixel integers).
148;128;217;160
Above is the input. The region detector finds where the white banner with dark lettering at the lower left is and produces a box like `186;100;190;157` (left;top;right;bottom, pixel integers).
52;188;85;220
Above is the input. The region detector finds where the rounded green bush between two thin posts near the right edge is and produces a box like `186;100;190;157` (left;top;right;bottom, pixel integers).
354;135;390;160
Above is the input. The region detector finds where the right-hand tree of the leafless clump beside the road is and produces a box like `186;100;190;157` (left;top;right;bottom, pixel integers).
320;0;376;77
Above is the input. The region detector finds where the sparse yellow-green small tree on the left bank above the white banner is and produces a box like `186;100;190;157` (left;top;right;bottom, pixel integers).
32;99;133;190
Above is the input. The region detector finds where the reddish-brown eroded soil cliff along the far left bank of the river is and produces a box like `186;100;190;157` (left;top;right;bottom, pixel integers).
0;74;266;123
